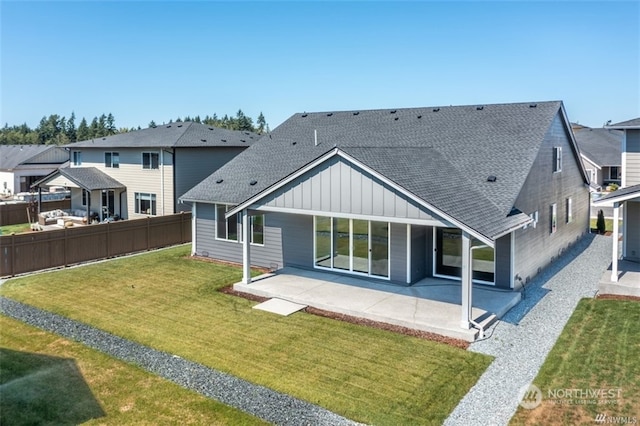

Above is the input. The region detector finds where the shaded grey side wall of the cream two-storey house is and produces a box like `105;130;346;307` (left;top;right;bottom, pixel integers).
173;147;245;212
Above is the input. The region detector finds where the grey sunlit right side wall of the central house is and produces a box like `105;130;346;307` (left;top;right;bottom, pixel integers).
510;114;589;289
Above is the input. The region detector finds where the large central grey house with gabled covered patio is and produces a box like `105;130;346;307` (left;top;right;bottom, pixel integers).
181;101;589;328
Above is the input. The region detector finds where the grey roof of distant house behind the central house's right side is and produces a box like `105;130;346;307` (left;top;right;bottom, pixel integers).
573;127;624;167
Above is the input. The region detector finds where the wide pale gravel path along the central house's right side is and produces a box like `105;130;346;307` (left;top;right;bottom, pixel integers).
445;235;611;426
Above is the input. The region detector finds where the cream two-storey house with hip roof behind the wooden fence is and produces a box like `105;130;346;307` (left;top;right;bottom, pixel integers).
37;122;259;220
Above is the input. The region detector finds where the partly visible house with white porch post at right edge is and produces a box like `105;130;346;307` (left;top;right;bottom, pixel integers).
594;118;640;282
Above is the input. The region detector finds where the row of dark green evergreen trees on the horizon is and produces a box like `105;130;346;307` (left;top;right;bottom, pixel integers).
0;110;269;145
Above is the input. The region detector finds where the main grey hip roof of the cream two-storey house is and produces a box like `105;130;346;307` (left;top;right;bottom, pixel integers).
66;121;260;149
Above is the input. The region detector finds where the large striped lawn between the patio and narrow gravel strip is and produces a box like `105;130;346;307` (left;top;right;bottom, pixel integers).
0;246;491;425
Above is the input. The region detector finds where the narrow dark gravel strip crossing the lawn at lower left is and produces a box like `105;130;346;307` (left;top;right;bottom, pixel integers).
0;297;359;425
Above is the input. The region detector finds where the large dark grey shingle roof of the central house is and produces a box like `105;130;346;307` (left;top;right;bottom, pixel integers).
181;101;586;239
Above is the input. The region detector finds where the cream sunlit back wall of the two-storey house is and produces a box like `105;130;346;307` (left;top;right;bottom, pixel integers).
72;148;175;219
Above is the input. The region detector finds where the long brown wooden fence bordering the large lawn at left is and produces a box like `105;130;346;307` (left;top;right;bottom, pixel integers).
0;213;191;277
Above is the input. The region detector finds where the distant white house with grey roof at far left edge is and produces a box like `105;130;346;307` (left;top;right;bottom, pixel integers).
0;145;69;196
